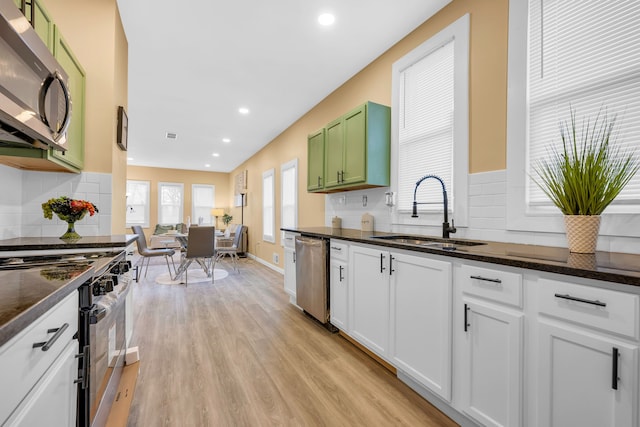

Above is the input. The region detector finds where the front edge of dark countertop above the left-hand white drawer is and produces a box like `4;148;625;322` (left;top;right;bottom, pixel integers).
0;267;95;347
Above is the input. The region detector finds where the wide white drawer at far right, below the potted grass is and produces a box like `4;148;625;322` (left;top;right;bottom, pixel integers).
537;279;638;339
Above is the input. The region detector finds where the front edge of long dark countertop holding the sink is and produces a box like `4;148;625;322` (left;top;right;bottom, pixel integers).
281;227;640;286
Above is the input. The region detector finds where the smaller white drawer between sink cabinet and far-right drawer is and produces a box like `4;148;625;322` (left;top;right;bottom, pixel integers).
457;265;522;308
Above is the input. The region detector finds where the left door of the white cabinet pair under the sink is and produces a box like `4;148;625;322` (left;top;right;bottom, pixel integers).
349;245;389;360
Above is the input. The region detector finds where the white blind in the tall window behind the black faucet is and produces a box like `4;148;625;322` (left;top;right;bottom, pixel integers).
398;40;455;211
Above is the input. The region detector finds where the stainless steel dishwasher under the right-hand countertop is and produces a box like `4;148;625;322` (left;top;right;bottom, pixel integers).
296;236;329;324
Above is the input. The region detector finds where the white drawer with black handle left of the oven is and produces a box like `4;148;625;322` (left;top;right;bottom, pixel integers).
0;291;78;424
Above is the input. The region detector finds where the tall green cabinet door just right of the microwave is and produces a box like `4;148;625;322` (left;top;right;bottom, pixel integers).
52;27;86;171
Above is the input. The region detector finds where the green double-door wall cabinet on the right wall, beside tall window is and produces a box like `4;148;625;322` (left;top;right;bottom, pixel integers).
309;102;391;193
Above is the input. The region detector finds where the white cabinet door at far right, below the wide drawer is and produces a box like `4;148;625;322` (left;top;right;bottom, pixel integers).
538;320;638;427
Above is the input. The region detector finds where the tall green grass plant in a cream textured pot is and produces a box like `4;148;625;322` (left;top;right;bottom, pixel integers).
533;109;640;253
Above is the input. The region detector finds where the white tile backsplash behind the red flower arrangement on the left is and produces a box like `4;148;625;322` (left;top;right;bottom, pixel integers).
0;165;112;239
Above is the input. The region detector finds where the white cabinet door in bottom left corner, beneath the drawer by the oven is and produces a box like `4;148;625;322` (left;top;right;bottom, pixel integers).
6;340;78;427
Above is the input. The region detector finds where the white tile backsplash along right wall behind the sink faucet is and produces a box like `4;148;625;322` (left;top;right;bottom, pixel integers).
325;170;640;254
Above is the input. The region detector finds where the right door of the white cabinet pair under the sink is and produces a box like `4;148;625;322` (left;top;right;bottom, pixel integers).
389;252;452;401
